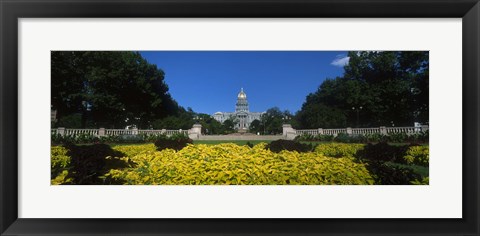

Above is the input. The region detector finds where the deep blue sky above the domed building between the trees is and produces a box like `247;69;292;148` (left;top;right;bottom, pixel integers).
140;51;349;114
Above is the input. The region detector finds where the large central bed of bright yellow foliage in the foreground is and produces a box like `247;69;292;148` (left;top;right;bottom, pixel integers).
107;143;374;185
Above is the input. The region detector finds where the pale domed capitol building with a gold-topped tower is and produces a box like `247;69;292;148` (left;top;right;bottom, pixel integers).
213;88;265;132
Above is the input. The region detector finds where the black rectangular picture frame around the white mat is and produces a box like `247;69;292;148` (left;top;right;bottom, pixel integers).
0;0;480;235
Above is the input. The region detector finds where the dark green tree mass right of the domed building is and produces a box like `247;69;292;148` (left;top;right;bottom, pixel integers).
295;51;429;128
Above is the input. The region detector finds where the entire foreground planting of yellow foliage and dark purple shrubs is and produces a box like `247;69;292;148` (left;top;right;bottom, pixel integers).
52;143;428;185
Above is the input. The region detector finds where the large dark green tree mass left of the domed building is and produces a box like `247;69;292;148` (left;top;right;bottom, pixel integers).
51;51;182;128
